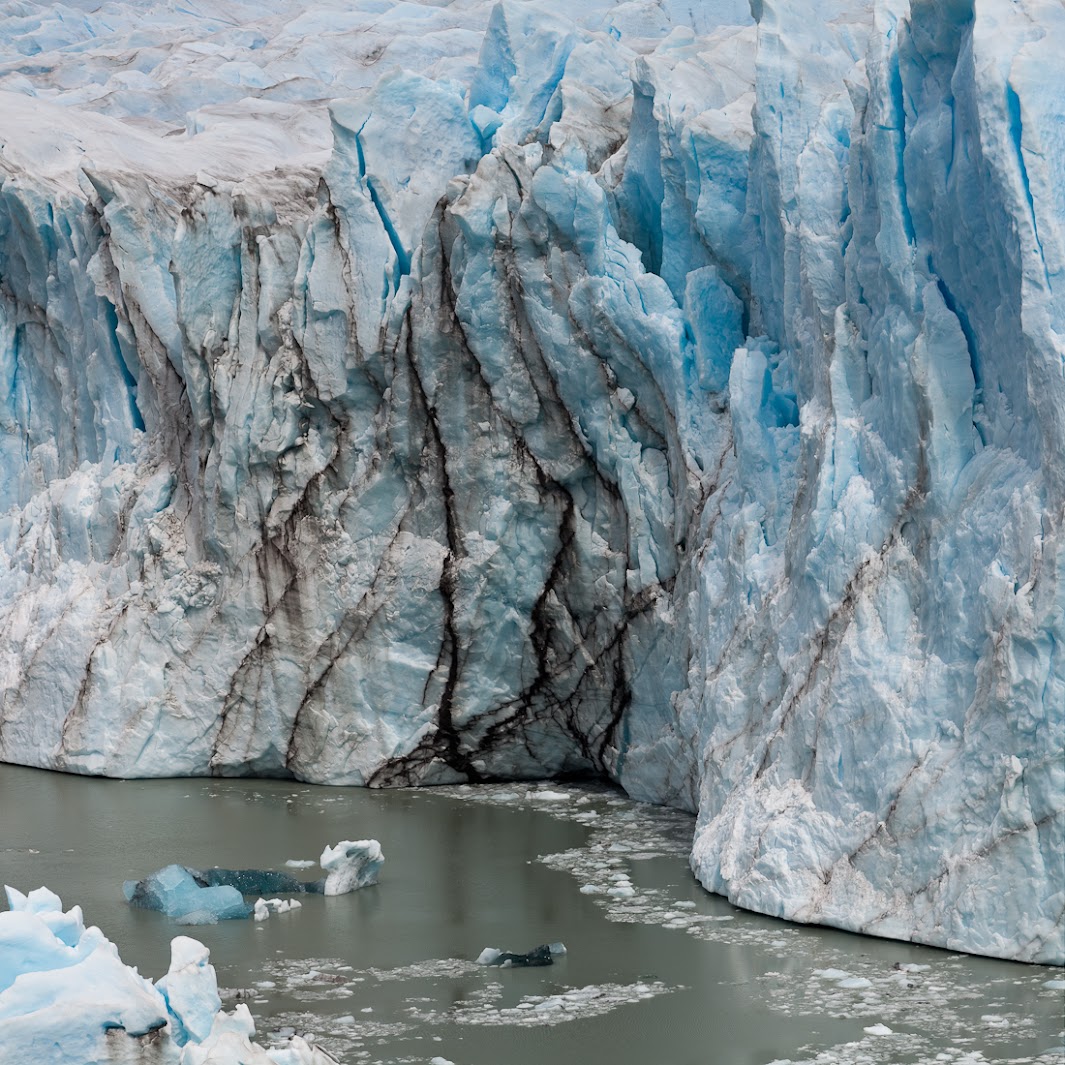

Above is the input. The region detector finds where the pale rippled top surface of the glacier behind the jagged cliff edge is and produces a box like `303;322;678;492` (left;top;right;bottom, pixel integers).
0;0;751;185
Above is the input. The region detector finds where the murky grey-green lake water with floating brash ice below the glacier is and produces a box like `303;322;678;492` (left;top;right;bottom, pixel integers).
0;766;1065;1065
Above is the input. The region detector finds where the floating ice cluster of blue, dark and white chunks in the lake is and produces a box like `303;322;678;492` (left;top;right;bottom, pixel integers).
122;839;384;924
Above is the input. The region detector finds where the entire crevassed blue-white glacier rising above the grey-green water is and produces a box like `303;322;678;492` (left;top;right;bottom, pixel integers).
0;0;1065;964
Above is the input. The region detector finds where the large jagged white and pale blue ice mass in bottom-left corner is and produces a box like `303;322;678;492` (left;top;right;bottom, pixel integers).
0;887;334;1065
